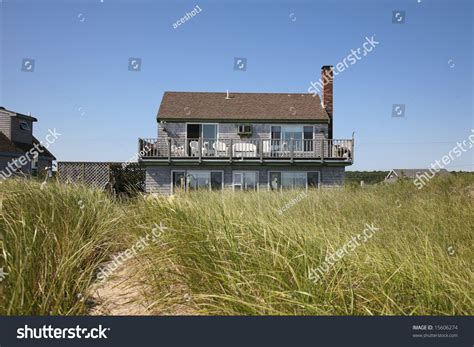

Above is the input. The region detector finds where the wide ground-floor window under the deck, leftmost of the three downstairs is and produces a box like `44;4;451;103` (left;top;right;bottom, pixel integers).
171;170;224;192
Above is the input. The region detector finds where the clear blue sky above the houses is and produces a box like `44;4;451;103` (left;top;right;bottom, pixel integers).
0;0;474;170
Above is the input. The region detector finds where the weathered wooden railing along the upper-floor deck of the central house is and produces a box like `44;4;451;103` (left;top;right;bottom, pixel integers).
139;138;354;162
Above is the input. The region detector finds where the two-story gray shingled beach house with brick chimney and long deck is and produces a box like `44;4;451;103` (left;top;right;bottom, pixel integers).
139;66;354;194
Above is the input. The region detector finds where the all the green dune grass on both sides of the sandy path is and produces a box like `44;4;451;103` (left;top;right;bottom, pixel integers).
0;176;474;315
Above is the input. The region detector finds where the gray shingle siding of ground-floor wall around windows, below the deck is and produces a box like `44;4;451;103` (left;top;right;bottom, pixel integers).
145;165;345;195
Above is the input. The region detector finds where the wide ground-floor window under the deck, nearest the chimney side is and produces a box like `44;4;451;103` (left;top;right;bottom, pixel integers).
268;171;320;191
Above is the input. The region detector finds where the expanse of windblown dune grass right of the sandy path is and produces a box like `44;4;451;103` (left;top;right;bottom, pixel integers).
139;178;474;315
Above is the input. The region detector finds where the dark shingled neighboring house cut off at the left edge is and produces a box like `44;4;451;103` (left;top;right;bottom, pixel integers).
0;107;56;178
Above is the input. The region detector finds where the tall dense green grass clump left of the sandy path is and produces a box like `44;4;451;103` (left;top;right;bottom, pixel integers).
0;179;130;315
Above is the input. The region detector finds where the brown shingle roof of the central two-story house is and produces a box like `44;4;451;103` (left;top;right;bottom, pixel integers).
157;92;329;122
